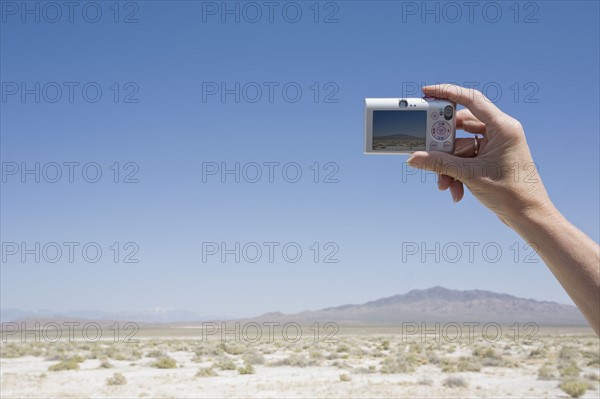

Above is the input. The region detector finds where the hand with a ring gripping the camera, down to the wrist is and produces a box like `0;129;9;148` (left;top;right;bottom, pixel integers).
407;84;553;226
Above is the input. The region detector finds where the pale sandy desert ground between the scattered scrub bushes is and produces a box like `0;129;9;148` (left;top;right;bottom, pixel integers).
0;334;600;398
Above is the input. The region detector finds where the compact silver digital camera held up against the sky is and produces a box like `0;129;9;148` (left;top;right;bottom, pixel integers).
365;97;456;154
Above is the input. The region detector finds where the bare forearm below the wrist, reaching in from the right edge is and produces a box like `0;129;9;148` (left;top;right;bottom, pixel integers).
507;203;600;336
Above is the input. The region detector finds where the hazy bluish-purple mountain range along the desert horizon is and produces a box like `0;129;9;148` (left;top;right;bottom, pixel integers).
0;287;587;326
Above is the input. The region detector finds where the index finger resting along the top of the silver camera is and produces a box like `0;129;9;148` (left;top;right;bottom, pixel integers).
423;83;504;125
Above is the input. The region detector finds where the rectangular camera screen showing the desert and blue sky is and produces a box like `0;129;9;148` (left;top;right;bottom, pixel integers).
373;110;427;151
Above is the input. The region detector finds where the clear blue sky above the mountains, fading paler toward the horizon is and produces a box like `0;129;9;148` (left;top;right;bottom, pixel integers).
0;1;600;316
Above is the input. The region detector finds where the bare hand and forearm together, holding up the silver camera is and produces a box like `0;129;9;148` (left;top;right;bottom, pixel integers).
407;84;600;336
